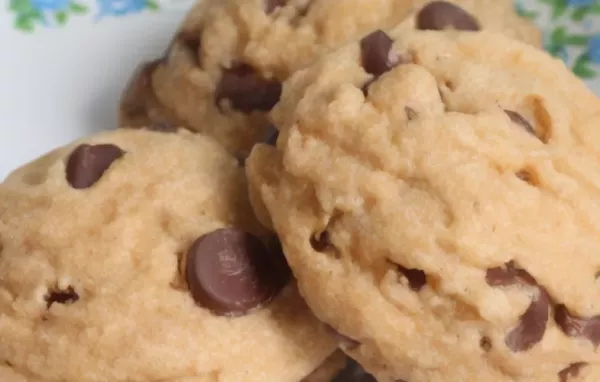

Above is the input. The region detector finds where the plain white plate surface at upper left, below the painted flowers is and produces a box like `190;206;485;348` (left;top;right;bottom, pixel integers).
0;0;195;180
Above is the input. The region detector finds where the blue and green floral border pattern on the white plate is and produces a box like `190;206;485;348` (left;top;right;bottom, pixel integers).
8;0;600;85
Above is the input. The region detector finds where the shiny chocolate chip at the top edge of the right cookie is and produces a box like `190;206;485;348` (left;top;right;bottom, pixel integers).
360;30;400;77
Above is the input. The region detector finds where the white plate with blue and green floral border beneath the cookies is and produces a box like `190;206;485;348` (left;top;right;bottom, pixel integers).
0;0;600;180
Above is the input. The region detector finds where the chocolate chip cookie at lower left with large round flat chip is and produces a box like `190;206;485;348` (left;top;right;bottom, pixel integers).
0;127;335;382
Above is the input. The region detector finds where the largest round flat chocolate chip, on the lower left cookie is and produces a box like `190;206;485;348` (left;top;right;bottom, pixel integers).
185;228;288;316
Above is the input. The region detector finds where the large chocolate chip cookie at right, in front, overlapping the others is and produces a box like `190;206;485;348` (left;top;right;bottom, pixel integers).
246;28;600;382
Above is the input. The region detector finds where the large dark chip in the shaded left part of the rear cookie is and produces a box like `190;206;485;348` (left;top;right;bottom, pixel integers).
215;64;281;113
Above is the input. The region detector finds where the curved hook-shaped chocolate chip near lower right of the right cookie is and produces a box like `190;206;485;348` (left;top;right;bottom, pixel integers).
485;261;550;352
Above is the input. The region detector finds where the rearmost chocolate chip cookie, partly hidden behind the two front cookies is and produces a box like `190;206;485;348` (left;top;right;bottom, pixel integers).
120;0;541;155
